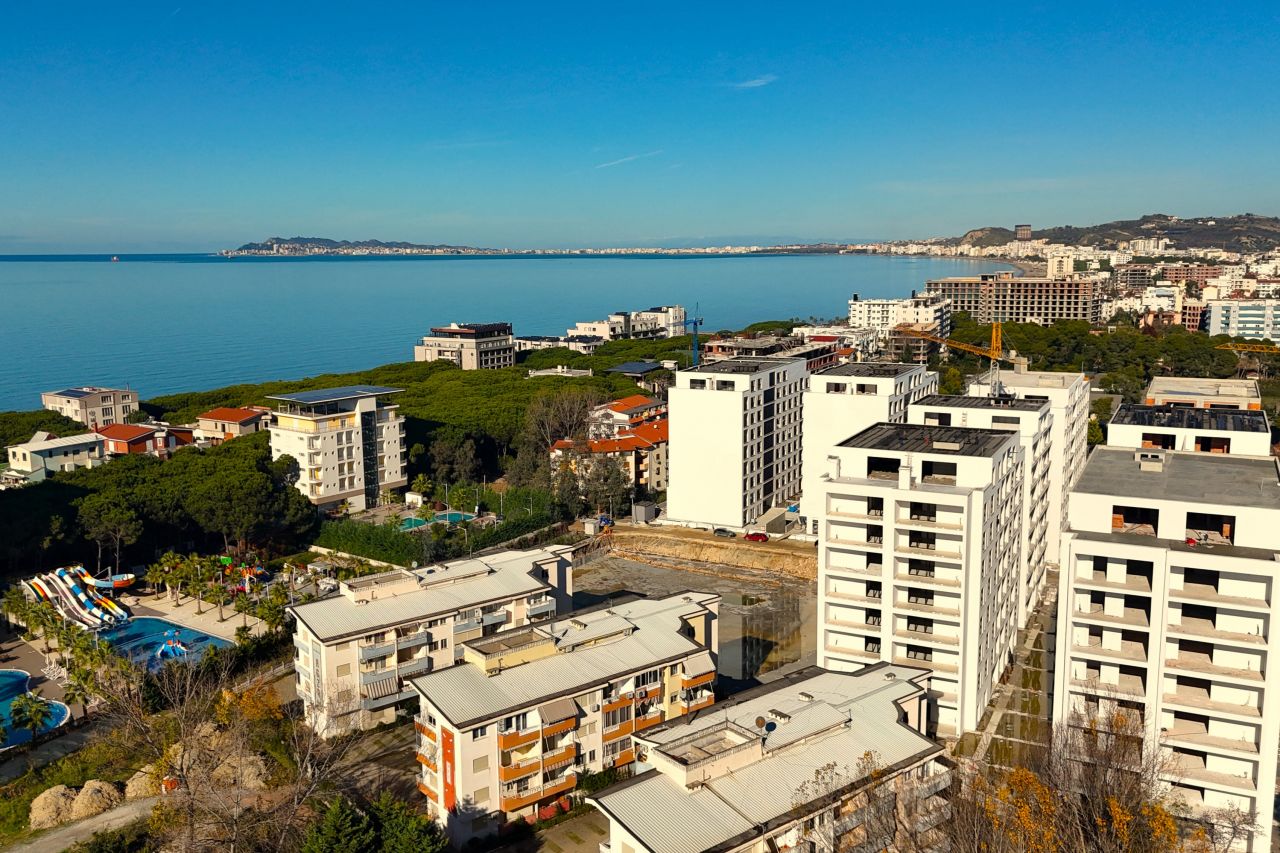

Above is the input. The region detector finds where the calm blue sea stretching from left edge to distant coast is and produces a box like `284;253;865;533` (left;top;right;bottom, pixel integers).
0;255;1004;410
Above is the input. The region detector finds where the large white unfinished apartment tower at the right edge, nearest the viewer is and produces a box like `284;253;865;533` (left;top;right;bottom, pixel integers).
1053;447;1280;850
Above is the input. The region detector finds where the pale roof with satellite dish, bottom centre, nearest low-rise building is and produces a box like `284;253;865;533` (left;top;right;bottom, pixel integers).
591;663;942;853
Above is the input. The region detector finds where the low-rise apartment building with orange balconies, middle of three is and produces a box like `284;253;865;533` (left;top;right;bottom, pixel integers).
412;592;719;847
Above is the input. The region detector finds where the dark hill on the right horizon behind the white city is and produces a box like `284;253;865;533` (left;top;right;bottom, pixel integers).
957;214;1280;252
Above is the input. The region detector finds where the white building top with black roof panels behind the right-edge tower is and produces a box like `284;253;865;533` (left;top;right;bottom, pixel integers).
1107;403;1271;456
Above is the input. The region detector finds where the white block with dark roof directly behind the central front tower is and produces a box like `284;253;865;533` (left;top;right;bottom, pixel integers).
908;394;1062;629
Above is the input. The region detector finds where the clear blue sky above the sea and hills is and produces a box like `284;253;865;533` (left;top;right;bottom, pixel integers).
0;0;1280;254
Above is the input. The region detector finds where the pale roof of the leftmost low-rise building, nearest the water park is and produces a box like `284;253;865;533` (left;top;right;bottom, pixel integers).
293;548;558;642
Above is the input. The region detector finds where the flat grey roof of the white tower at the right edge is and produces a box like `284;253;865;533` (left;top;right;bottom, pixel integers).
1073;447;1280;510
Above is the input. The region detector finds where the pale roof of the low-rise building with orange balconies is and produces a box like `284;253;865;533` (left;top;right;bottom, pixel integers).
413;593;719;727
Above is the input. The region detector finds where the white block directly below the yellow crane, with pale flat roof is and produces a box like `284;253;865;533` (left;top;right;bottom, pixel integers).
969;369;1089;562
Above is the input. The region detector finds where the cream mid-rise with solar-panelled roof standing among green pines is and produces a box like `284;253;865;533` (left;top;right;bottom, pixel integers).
268;386;408;511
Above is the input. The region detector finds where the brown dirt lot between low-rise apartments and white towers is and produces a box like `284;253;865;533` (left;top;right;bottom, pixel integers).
573;550;817;692
